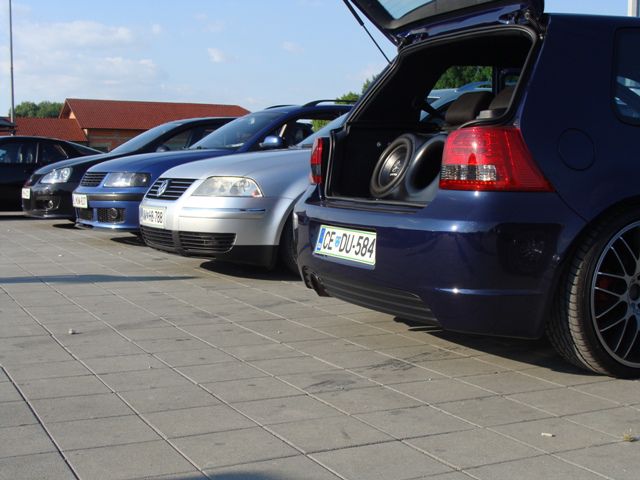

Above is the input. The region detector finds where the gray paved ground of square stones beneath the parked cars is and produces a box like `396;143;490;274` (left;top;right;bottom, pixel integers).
0;216;640;480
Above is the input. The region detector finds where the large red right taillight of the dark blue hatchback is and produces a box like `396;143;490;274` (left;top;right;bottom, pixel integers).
440;127;553;192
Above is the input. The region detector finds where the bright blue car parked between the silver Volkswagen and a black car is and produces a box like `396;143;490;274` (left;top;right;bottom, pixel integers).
73;100;351;232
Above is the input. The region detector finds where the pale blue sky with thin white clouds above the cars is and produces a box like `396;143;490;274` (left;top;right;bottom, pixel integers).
0;0;628;115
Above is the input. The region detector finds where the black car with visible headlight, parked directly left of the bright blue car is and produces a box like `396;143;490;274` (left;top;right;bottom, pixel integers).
22;117;234;220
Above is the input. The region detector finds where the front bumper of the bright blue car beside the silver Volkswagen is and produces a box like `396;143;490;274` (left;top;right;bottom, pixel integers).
74;187;146;232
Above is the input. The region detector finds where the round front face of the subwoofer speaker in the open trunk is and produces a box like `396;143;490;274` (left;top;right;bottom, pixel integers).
369;133;423;198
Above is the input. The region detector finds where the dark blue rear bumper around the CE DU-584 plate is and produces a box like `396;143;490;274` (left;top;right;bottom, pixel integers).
295;191;584;338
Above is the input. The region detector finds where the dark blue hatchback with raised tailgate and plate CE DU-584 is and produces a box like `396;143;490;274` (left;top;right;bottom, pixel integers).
295;0;640;377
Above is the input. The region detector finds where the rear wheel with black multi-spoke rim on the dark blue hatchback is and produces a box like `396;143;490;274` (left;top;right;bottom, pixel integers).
547;210;640;378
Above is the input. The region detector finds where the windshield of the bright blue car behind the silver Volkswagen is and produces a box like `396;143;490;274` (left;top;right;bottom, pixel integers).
189;110;283;150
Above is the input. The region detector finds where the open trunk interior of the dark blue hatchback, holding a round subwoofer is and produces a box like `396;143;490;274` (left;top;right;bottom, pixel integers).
325;26;536;205
